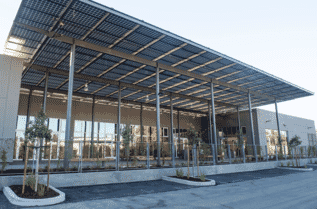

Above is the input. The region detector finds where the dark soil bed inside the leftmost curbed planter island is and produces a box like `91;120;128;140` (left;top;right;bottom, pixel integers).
10;185;59;199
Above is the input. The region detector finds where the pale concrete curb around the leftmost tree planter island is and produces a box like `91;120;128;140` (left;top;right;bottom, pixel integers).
3;186;65;206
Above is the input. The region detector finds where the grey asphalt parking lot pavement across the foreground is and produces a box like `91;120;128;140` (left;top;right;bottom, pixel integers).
0;166;317;209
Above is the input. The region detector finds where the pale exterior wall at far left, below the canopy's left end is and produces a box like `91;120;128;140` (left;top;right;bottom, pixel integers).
0;55;23;162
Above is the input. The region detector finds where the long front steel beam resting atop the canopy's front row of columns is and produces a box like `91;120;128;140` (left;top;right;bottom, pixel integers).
16;23;275;101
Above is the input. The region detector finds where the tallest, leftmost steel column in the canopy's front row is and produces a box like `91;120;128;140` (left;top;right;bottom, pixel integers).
64;44;76;169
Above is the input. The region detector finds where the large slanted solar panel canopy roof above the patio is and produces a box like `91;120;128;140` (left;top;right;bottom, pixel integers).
5;0;313;113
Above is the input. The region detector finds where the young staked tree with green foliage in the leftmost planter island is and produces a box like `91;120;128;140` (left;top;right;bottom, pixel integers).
23;108;52;193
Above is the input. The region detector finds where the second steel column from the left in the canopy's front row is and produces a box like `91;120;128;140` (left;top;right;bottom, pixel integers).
156;66;161;166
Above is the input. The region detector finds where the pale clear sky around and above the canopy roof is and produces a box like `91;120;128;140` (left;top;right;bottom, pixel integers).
0;0;317;128
